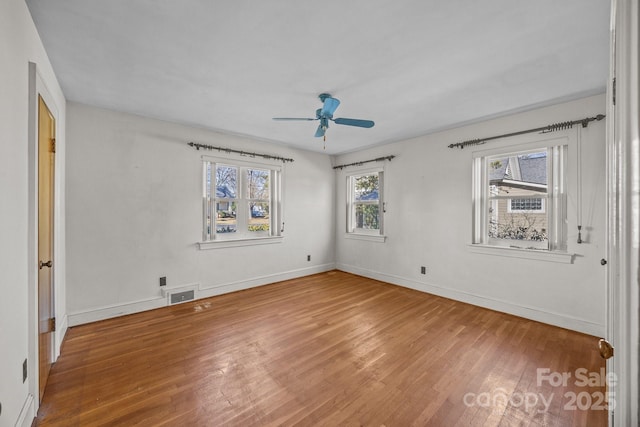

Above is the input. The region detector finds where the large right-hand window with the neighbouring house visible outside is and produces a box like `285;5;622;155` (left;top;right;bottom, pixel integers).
473;138;568;252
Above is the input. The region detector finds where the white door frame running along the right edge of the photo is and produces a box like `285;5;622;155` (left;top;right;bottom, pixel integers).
606;0;640;426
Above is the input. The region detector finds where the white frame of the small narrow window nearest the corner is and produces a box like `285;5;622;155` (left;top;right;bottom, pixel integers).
345;167;386;242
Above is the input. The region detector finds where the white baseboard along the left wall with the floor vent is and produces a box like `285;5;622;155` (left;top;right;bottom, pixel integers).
67;263;336;327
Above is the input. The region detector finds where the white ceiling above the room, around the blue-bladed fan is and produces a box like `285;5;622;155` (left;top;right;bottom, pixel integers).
26;0;609;154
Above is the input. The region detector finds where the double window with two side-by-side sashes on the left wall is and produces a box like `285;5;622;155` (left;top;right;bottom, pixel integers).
203;159;281;246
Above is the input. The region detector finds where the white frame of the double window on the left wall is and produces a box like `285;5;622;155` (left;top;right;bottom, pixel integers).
198;156;284;249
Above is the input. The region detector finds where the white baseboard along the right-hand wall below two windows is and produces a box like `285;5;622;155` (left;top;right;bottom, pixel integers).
336;264;606;337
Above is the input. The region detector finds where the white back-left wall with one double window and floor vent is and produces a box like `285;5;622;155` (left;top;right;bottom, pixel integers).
67;103;335;325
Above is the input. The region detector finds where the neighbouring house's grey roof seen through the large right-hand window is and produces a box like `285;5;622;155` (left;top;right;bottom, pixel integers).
489;155;547;191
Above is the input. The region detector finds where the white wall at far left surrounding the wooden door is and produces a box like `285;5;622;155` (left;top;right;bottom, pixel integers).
0;0;65;427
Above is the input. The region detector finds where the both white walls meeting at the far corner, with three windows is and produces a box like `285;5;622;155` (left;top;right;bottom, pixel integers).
67;96;605;335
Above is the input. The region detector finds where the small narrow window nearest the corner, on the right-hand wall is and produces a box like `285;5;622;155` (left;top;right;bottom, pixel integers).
347;170;384;236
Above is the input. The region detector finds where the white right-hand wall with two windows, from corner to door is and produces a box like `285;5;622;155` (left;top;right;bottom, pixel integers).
334;95;606;335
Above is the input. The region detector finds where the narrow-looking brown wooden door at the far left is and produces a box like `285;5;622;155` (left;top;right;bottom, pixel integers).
38;96;55;401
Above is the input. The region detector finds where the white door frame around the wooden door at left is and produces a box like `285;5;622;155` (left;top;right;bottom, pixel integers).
27;62;66;416
